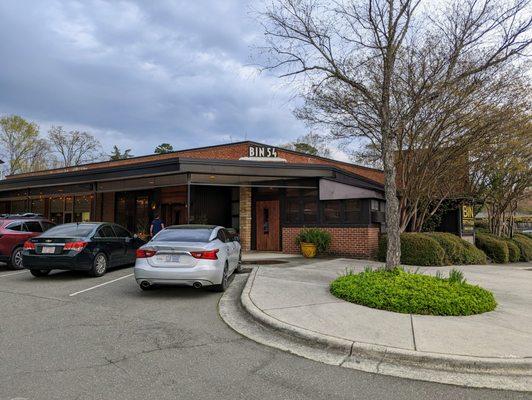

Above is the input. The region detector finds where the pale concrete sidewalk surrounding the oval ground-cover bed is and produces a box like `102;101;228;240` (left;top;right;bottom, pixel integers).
222;259;532;390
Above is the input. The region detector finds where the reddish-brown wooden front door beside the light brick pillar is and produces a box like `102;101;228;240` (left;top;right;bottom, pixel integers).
255;200;280;251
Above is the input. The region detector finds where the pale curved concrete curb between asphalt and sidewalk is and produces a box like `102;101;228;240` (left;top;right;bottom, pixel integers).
229;267;532;391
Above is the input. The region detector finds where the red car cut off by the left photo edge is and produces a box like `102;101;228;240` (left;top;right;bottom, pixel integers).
0;214;55;269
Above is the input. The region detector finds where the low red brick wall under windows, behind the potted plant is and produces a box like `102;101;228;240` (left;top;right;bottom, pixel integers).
283;227;379;258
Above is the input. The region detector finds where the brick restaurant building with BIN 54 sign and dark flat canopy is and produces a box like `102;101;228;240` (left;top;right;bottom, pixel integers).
0;141;384;257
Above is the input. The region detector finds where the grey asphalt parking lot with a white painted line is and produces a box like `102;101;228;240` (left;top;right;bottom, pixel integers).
0;268;530;400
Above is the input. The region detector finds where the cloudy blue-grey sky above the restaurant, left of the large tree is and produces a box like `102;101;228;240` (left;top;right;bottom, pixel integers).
0;0;336;159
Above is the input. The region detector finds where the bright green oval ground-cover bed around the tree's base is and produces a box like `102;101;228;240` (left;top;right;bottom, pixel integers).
330;268;497;315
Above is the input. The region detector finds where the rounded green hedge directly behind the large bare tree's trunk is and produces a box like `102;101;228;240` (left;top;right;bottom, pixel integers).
377;232;445;266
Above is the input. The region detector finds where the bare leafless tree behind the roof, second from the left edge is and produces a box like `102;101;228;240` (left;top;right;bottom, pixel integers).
48;126;102;167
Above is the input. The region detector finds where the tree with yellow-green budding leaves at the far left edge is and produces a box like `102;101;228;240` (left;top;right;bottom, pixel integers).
0;115;50;174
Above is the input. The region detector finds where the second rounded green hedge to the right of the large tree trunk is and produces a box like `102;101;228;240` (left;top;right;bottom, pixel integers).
425;232;487;265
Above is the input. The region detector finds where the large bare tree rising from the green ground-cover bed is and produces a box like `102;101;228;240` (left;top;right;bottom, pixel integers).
263;0;532;268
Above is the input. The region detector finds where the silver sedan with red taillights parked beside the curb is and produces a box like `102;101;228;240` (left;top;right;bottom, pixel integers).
133;225;242;291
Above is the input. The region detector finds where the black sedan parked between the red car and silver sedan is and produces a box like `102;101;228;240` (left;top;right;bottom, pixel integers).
22;222;145;276
